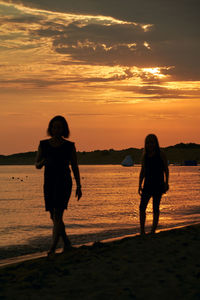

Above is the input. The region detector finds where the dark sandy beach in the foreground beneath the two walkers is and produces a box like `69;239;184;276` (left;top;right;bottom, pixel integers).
0;224;200;300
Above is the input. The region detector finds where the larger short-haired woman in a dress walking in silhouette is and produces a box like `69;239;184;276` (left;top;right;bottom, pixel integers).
35;116;82;255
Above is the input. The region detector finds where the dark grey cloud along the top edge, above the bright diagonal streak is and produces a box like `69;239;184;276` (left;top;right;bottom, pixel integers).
5;0;200;34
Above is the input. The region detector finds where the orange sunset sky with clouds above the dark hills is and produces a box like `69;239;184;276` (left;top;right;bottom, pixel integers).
0;0;200;154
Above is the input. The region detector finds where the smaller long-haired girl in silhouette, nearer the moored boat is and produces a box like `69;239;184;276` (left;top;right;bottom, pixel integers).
138;134;169;235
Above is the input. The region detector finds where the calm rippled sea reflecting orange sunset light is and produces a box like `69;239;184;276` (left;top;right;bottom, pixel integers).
0;165;200;257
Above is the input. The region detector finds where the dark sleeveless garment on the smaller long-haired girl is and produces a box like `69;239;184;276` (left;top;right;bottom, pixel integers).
143;153;164;195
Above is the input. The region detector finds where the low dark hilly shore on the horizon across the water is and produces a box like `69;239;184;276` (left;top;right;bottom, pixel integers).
0;143;200;165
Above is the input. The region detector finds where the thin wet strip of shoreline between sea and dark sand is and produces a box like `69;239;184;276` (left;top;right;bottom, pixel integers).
0;222;200;269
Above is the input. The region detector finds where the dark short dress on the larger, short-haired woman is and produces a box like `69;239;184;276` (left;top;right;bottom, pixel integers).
40;140;75;211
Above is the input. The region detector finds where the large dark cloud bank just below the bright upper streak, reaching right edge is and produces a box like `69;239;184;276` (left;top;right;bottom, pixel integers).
30;17;200;80
